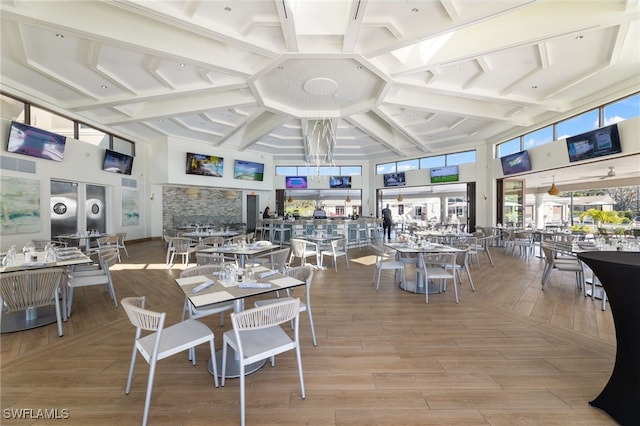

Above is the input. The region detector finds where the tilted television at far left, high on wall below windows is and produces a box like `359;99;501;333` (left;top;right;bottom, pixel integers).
7;121;67;161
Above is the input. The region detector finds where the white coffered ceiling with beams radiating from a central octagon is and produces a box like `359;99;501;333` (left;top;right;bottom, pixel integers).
1;0;640;171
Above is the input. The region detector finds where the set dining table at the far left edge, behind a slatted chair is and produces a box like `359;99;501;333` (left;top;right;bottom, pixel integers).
0;247;93;333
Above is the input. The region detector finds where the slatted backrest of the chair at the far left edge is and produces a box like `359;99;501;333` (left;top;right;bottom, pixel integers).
0;268;65;312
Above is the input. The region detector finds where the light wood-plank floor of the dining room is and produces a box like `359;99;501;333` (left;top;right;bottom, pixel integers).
0;241;615;425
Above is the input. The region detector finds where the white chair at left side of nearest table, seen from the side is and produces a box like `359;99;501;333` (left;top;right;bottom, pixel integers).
120;297;218;426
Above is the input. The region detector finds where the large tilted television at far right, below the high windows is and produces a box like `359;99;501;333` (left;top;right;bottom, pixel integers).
567;124;622;162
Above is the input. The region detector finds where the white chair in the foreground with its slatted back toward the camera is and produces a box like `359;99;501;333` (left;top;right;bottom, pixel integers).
222;299;305;426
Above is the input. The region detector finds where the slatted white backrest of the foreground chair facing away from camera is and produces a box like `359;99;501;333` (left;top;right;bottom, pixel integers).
231;298;300;332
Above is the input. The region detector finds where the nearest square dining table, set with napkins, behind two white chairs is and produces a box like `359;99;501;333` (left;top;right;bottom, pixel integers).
176;266;305;378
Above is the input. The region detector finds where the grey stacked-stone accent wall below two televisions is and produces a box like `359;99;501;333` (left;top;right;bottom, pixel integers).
162;186;242;229
